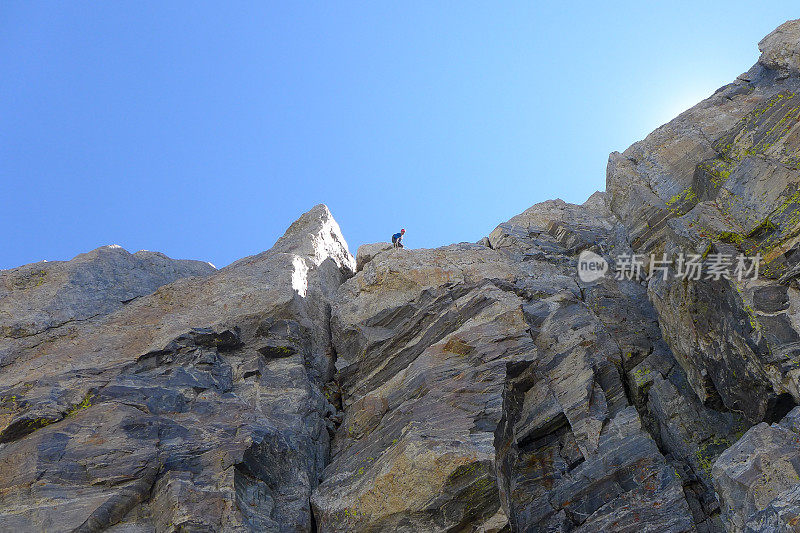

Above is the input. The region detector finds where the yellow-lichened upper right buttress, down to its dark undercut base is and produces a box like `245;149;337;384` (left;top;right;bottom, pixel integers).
607;42;800;423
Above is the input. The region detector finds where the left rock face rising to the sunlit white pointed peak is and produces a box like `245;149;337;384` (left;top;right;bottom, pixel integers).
0;206;355;531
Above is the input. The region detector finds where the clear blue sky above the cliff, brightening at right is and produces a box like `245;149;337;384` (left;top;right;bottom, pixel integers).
0;0;800;268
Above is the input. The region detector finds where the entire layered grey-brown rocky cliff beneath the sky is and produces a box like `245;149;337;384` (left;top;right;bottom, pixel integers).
0;21;800;533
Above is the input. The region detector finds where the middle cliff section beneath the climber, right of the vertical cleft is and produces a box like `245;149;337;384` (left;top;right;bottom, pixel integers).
312;194;708;531
